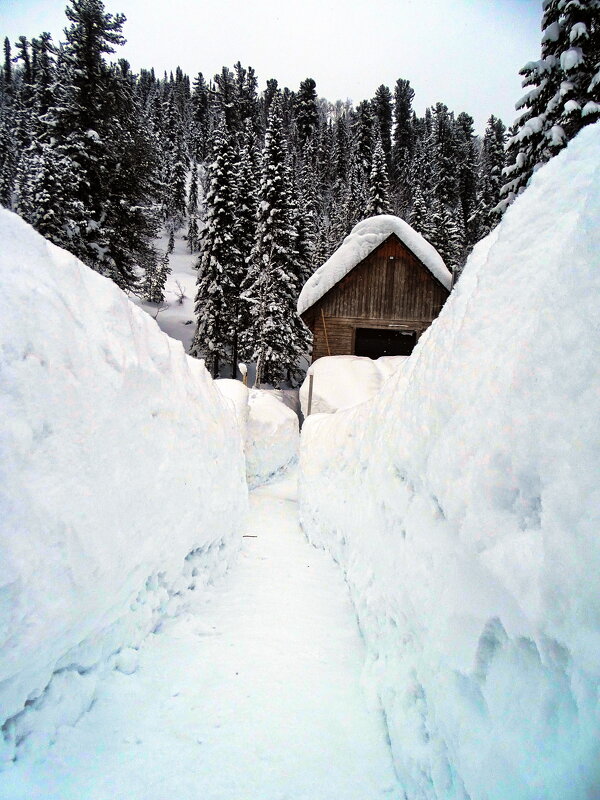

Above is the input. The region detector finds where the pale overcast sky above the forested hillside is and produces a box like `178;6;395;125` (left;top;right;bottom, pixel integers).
0;0;541;131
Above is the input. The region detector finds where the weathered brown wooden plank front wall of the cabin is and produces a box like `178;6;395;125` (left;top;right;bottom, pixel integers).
302;234;448;361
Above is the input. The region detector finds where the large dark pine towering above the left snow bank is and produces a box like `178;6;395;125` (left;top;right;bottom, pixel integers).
20;0;161;288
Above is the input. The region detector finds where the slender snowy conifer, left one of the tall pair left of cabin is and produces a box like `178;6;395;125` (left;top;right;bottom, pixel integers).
190;117;240;378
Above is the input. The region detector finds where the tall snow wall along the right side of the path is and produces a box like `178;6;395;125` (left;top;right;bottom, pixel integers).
300;125;600;800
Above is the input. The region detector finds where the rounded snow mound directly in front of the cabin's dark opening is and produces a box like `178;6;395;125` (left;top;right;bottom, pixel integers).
300;356;408;417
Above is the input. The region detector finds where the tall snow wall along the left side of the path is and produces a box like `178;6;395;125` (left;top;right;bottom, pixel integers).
0;211;247;764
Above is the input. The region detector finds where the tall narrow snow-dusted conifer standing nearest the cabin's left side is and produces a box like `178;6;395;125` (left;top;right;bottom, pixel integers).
244;93;307;386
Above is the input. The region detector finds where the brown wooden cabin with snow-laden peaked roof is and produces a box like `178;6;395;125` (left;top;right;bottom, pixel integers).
298;215;452;361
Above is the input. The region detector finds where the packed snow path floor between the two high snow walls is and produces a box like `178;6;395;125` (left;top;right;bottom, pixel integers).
0;474;402;800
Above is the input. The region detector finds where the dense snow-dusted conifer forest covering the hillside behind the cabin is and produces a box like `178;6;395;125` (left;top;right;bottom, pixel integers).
0;0;600;382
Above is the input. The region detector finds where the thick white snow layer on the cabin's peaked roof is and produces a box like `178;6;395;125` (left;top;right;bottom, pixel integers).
298;214;452;314
